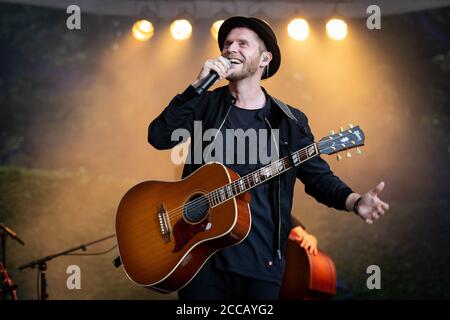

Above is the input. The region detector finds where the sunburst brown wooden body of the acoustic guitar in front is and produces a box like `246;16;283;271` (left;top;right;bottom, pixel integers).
116;163;251;292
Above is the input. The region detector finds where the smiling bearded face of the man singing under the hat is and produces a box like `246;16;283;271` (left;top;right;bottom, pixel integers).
222;28;262;81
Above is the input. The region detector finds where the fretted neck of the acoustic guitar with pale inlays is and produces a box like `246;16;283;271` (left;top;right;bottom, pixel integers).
206;143;319;207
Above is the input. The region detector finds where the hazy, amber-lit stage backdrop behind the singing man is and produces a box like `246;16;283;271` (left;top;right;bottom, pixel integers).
0;3;450;299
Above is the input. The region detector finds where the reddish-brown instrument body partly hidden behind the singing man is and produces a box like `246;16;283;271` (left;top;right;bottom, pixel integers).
280;240;336;300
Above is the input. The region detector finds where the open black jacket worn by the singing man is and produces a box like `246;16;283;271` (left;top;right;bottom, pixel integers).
148;86;352;259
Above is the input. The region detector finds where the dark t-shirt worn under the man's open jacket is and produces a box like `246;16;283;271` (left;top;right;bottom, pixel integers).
212;99;284;283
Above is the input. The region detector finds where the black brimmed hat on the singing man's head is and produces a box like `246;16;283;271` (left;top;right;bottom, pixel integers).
217;16;281;79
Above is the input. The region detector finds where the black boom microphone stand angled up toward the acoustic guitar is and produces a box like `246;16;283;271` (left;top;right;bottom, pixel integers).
19;234;116;300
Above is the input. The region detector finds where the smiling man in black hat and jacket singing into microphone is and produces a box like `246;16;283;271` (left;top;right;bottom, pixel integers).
148;17;389;299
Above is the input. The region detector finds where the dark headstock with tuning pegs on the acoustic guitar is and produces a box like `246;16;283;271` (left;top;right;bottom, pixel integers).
317;124;364;160
